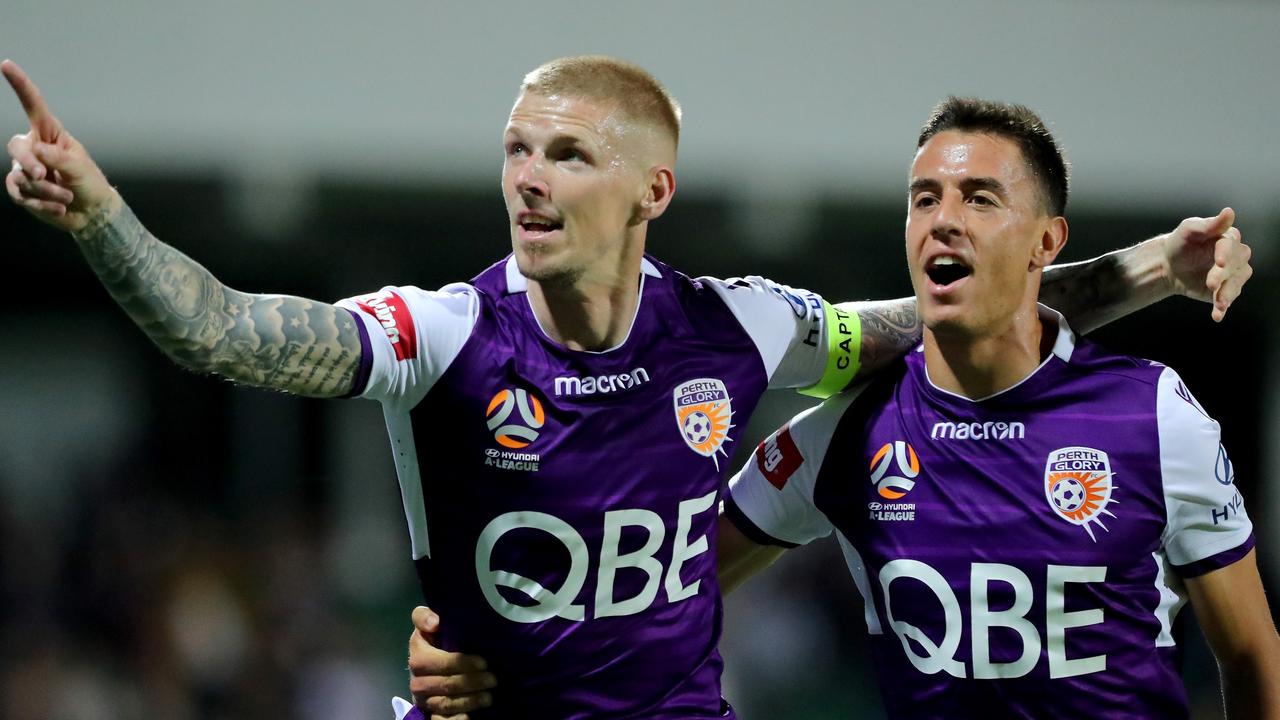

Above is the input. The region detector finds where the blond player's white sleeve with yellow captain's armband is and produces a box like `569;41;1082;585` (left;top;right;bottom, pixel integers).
699;275;861;397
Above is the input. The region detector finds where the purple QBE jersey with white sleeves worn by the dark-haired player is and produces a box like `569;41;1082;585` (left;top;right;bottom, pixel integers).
726;304;1253;719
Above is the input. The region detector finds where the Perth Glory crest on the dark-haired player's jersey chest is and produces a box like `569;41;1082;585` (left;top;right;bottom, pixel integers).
1044;447;1115;542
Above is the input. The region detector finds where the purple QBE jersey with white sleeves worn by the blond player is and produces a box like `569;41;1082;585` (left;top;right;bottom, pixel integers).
340;259;847;719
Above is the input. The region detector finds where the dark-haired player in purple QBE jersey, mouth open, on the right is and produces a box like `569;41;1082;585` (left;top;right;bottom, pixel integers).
721;99;1280;719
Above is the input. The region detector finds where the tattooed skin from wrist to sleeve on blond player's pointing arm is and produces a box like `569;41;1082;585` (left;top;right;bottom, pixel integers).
76;198;361;397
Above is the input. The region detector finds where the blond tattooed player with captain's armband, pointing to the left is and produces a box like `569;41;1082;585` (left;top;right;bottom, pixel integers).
4;56;1248;719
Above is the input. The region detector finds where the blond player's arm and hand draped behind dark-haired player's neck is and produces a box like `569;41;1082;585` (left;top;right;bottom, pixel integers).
838;208;1253;382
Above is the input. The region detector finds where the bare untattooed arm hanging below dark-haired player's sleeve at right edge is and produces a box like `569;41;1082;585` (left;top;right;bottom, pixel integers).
1185;550;1280;720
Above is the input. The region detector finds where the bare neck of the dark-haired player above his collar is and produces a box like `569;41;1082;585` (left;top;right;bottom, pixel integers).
924;305;1057;400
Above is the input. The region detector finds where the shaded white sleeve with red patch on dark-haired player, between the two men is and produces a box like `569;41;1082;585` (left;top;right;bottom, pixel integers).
726;383;867;547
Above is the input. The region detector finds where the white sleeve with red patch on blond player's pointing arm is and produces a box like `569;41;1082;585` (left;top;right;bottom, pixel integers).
337;283;480;410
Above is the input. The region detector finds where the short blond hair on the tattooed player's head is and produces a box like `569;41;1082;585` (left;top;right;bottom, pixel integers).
520;55;680;146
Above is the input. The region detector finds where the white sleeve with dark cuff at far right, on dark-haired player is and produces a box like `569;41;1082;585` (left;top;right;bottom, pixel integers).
1156;368;1253;575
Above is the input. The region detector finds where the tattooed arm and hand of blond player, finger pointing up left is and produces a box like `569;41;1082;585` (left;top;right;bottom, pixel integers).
0;60;361;397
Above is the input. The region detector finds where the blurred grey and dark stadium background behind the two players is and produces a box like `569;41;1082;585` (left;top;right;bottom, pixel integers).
0;0;1280;720
